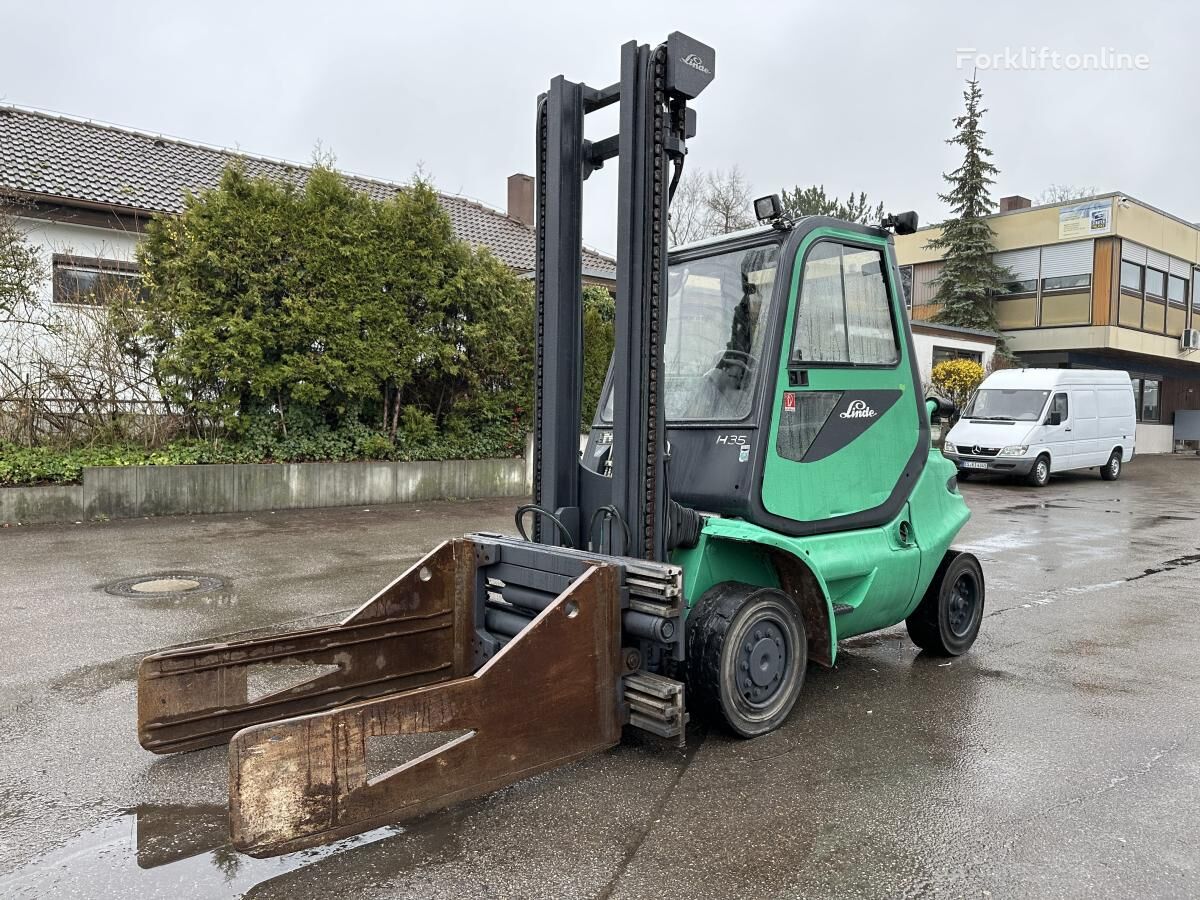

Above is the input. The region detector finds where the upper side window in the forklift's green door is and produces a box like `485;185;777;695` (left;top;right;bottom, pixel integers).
791;241;900;366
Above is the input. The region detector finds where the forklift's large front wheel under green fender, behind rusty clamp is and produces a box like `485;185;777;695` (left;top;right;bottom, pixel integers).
688;581;809;738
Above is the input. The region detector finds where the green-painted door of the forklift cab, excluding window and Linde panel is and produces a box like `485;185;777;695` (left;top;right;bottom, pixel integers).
762;228;924;522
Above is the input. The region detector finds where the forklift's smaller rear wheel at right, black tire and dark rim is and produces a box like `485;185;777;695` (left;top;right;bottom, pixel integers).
905;551;984;656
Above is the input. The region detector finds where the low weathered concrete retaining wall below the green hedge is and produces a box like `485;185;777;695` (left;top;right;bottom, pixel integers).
0;458;530;524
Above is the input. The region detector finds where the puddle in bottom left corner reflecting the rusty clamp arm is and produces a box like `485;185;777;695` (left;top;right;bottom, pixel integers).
0;805;404;900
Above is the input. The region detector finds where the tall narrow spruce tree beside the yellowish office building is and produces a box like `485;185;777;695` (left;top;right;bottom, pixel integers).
926;73;1009;331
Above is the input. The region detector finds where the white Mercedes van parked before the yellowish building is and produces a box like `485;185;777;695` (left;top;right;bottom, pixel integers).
942;368;1136;487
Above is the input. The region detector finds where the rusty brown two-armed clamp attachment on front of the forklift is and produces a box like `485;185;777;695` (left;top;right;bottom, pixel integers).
138;535;686;856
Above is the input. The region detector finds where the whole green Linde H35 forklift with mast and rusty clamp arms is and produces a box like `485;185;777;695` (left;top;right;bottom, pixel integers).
138;32;984;856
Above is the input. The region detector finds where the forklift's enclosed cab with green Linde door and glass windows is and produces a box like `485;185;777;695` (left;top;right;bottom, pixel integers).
583;217;929;535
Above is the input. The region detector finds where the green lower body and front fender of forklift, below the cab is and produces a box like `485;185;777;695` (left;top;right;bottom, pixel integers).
672;450;971;659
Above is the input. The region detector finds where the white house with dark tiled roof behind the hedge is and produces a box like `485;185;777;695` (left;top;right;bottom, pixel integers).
0;104;616;415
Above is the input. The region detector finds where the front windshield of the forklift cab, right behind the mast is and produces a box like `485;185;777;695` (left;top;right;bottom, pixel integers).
601;244;779;421
